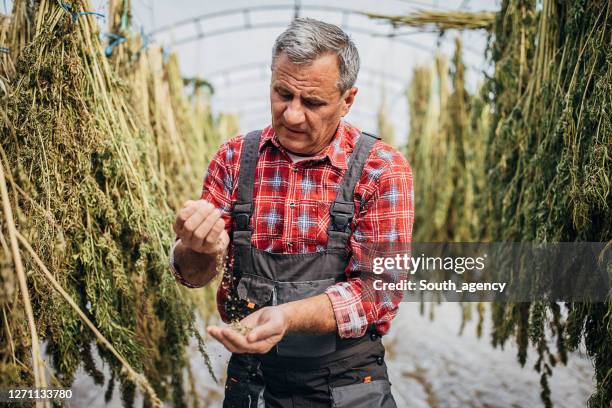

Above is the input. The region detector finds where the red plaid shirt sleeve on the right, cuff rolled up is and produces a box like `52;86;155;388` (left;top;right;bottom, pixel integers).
326;143;414;337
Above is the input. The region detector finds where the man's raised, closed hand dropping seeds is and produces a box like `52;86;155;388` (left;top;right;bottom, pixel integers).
173;200;229;255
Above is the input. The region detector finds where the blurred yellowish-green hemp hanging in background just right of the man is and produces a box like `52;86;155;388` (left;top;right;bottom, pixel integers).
406;39;489;242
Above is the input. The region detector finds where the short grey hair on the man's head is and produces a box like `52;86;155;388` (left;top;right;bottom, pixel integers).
272;18;359;93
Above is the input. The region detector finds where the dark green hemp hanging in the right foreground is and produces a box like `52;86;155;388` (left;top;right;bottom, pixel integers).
486;0;612;407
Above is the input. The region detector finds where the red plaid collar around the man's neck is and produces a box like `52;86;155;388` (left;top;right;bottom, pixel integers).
259;121;359;170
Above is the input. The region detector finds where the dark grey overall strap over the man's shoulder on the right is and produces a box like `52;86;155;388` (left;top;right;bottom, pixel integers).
327;132;380;249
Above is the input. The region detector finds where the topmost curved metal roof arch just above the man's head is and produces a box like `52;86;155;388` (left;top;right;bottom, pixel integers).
148;5;482;56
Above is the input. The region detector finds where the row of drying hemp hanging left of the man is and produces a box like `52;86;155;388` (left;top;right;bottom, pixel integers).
0;0;233;406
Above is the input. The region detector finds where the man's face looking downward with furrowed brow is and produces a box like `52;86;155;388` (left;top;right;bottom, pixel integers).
270;53;357;156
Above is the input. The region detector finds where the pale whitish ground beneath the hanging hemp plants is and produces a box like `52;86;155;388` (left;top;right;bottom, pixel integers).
65;303;595;408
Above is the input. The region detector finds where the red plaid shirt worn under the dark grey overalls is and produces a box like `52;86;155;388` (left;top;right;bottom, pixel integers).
173;122;414;337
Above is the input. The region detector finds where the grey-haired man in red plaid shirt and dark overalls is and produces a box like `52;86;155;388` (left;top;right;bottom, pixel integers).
171;19;413;407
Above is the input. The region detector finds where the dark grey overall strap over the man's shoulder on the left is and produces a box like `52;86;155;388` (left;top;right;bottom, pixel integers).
232;130;261;246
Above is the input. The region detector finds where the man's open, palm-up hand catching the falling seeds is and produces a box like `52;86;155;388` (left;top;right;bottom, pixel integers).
207;306;289;354
